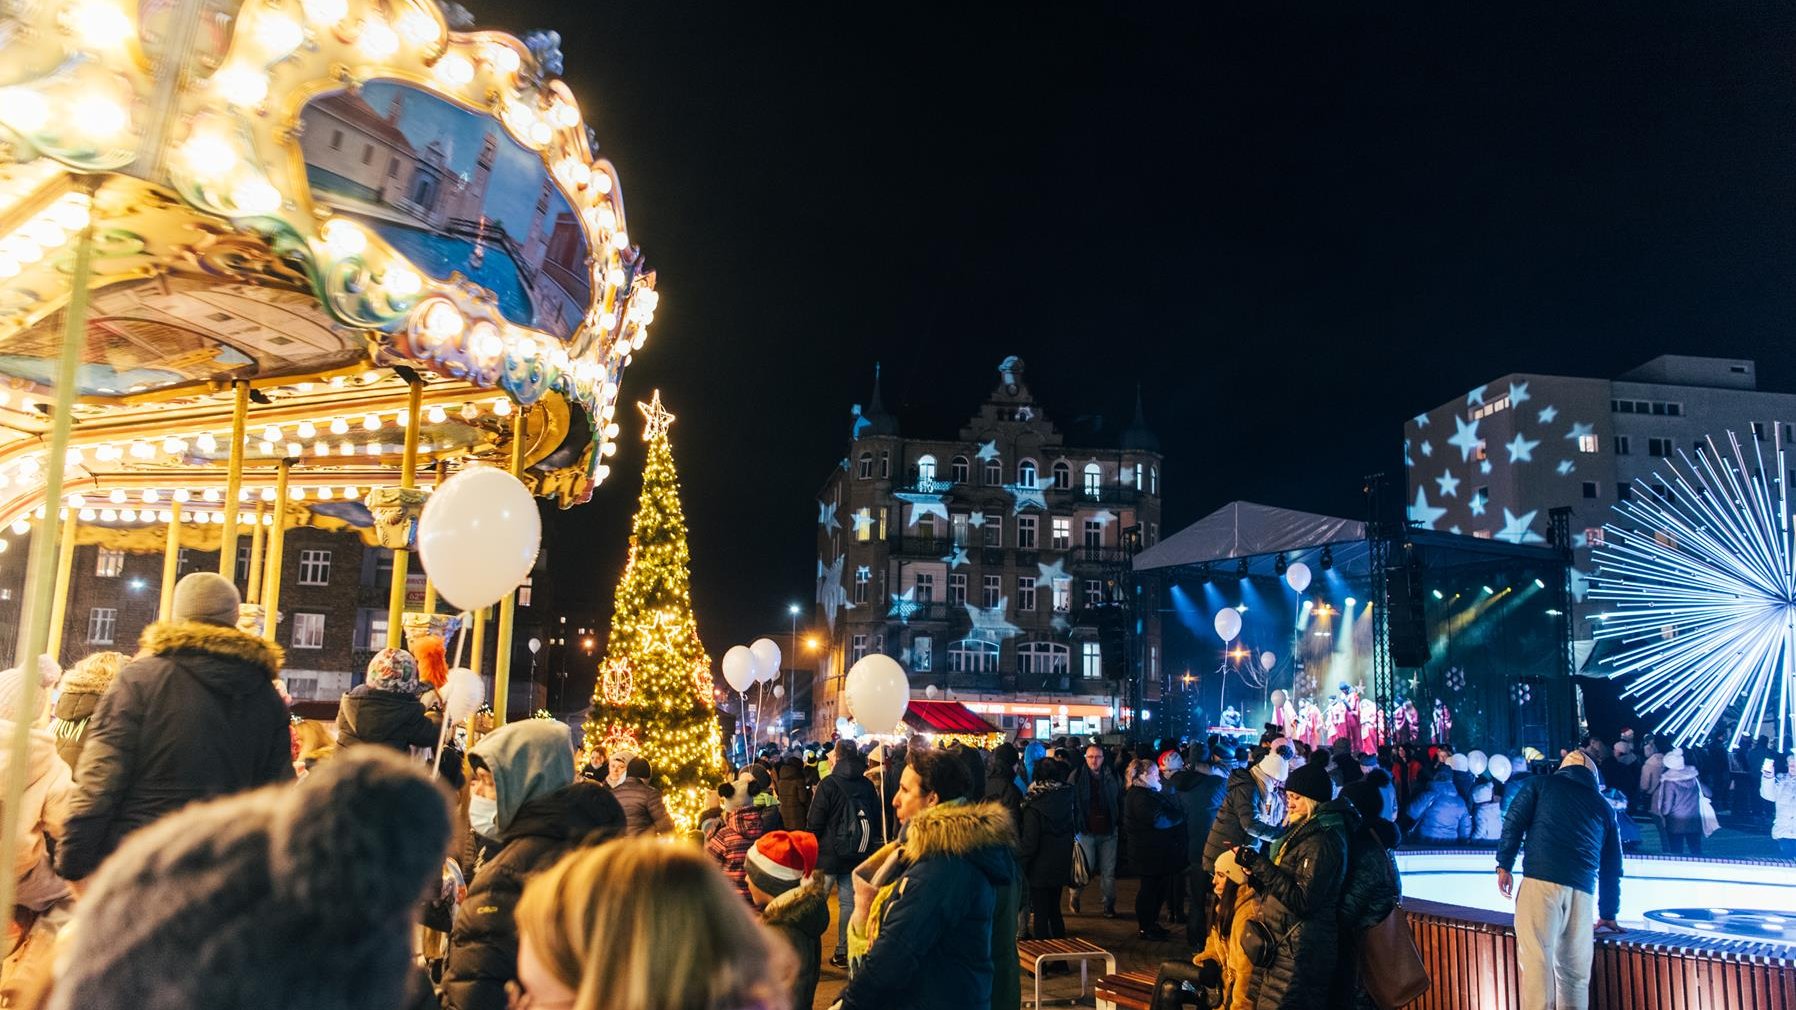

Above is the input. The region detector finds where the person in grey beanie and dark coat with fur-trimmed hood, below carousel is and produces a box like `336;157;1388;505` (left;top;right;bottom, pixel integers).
56;571;293;881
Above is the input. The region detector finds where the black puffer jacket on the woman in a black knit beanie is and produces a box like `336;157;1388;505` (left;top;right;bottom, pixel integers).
1246;800;1360;1010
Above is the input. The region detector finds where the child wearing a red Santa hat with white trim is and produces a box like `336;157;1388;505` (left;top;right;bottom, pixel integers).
747;830;830;1008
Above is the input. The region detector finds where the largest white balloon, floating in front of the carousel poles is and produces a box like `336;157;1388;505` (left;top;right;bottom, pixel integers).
418;467;542;611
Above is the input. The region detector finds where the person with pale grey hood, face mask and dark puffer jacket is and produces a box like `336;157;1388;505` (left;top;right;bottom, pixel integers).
440;719;623;1010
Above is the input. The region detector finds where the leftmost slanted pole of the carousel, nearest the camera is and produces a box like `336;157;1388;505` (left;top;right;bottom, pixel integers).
0;196;93;909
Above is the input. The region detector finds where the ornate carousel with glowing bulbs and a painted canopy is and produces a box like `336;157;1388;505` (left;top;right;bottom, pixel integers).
0;0;656;900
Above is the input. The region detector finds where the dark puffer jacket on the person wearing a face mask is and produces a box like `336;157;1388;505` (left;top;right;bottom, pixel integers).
442;780;623;1010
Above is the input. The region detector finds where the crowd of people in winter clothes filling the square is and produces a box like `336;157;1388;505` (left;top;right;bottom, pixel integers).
0;573;1796;1010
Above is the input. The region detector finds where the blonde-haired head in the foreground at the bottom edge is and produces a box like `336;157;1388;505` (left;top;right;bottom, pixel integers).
517;837;796;1010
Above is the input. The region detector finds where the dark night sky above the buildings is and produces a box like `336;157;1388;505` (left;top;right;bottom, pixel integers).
474;0;1796;654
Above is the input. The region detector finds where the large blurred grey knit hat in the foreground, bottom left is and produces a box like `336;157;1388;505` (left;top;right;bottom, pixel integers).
50;748;449;1010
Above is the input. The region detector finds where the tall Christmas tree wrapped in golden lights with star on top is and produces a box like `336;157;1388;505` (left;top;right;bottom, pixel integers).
585;390;724;830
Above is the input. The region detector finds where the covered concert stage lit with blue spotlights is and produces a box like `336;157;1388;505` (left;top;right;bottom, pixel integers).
1135;501;1577;753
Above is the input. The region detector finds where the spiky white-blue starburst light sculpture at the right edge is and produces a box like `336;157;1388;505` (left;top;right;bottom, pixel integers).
1589;424;1796;753
